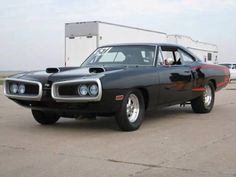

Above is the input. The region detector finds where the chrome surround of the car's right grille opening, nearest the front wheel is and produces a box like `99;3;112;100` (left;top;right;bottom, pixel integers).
51;78;102;102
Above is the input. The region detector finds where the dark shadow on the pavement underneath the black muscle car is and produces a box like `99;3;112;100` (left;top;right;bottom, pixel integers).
34;106;194;132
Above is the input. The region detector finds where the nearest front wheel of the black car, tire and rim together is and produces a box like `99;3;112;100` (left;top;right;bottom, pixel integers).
116;89;145;131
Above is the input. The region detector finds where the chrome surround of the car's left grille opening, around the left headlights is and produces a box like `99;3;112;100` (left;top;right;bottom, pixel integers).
4;78;43;101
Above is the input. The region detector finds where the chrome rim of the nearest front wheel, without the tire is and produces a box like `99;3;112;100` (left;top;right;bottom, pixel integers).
126;94;139;123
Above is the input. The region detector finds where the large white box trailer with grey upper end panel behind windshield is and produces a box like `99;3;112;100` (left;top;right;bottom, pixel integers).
65;21;167;66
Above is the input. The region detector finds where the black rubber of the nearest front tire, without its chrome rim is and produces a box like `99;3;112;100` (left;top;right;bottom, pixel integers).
116;89;145;131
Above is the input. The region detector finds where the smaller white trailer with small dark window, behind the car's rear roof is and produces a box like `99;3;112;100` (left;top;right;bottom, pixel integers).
167;35;218;64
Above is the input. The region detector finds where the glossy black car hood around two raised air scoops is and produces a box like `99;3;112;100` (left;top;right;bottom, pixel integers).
10;66;126;83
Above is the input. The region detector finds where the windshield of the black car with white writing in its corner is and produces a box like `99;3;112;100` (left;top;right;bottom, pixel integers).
82;45;155;66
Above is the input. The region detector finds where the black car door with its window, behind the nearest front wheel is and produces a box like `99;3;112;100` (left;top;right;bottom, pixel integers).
158;46;192;104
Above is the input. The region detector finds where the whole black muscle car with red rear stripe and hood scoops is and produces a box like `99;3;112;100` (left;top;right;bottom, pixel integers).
4;44;230;131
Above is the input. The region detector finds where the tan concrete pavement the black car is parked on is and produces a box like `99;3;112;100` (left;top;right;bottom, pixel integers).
0;83;236;177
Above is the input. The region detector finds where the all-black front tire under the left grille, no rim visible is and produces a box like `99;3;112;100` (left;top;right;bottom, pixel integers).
32;110;60;125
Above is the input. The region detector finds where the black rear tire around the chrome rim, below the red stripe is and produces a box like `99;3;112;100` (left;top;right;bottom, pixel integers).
191;82;215;113
